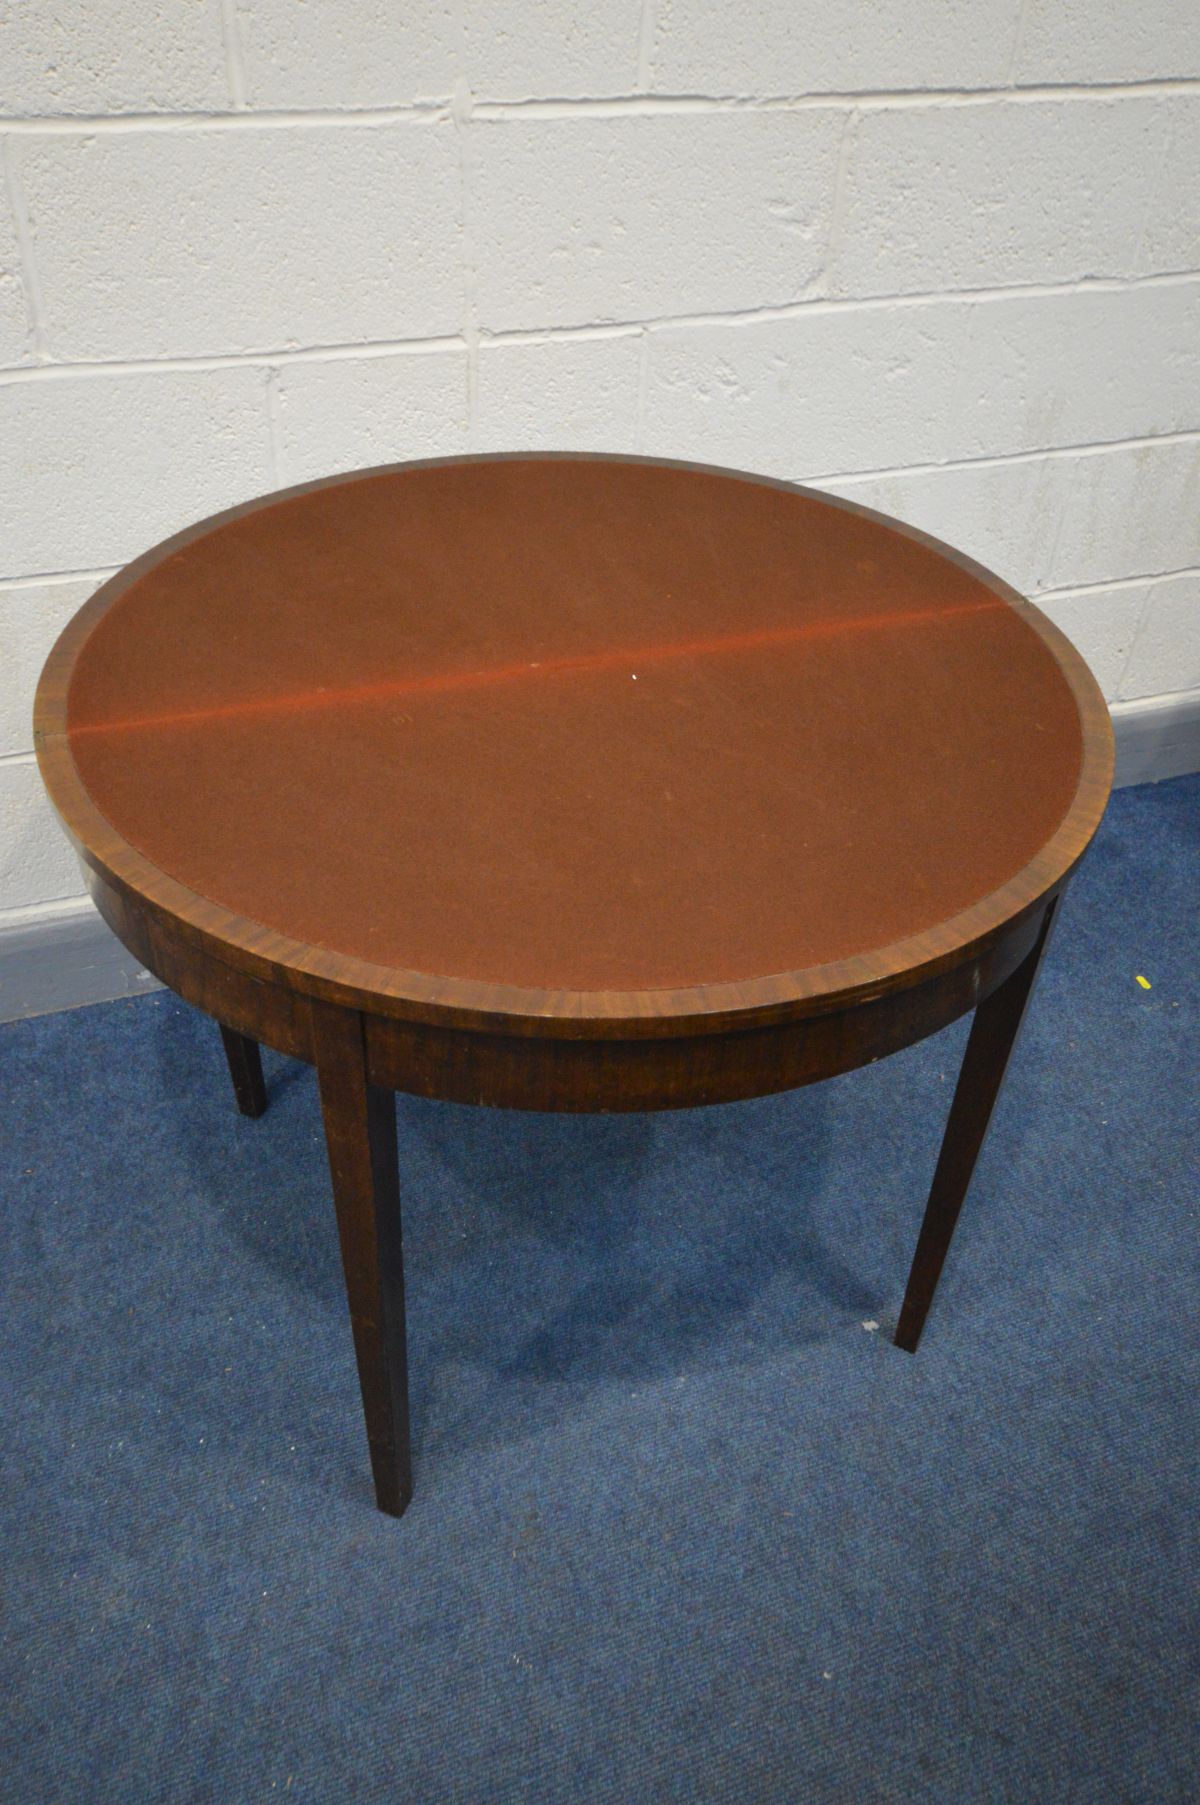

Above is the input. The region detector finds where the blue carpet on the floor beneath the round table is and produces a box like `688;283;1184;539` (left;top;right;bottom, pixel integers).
0;778;1200;1805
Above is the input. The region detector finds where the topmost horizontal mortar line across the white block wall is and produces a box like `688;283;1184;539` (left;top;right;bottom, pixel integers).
0;76;1200;137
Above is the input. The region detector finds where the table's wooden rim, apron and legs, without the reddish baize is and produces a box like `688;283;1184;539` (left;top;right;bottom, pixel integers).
34;453;1113;1514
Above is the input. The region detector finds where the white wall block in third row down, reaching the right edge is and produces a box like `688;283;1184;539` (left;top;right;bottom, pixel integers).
646;280;1200;477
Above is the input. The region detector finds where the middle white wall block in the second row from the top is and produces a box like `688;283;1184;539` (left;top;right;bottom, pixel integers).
467;108;843;332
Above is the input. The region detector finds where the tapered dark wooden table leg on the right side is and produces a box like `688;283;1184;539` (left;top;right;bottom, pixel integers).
895;892;1061;1354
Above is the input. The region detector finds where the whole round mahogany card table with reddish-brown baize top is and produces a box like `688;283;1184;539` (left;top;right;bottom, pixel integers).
36;455;1112;1514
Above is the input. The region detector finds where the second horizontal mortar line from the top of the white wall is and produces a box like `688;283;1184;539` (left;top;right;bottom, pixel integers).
0;269;1200;388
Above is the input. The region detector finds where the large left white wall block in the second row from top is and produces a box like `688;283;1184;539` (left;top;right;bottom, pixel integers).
21;121;462;363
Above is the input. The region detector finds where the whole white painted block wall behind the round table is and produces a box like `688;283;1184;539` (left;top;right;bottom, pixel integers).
0;0;1200;922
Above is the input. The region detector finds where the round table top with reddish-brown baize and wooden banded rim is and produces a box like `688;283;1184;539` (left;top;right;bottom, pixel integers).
38;455;1112;1018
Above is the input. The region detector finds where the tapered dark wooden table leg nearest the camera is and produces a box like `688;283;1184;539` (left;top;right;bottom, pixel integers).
312;998;413;1516
